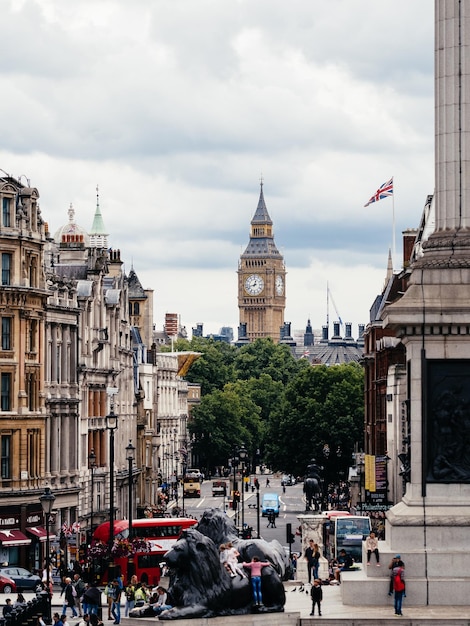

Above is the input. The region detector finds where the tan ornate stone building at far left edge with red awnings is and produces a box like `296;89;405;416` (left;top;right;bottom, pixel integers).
0;176;48;567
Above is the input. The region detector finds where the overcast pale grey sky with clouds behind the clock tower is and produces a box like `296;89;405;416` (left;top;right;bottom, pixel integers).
0;0;434;336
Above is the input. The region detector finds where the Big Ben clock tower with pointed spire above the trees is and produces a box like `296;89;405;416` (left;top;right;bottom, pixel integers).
238;182;286;343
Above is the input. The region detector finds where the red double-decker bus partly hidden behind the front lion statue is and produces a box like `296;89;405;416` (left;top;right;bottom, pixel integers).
92;517;197;586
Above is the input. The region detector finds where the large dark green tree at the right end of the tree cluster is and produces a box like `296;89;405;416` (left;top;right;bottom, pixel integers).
266;363;364;475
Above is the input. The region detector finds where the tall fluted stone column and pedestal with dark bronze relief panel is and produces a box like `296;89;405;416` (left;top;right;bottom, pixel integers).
383;0;470;605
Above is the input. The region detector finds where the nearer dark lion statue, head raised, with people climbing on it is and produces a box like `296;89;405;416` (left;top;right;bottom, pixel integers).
159;528;285;620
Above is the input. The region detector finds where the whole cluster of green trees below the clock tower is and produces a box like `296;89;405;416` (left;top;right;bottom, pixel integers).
177;338;364;476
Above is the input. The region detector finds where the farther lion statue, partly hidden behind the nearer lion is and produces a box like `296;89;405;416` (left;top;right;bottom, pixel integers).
196;509;292;580
